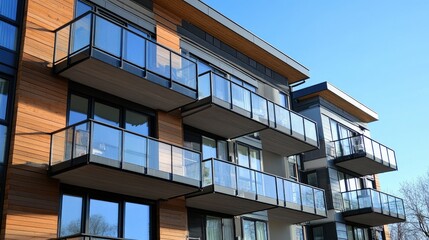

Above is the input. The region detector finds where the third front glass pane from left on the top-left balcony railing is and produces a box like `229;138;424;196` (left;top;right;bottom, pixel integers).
147;41;170;78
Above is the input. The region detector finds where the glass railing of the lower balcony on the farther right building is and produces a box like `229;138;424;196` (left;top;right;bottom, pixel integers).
342;189;405;219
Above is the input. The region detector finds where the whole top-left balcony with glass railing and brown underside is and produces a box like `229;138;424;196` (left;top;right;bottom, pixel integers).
54;12;197;111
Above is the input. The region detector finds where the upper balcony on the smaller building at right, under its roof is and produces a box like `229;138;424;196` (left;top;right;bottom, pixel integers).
333;135;397;176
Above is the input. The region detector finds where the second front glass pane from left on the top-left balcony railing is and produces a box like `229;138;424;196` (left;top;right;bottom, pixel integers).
124;30;146;68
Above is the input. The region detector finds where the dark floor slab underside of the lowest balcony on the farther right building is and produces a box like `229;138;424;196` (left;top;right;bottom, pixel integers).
343;208;405;227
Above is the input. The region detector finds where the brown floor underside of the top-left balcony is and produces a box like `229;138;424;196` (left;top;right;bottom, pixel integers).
55;50;196;111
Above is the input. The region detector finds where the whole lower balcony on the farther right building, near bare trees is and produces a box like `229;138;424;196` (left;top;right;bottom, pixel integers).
342;189;405;227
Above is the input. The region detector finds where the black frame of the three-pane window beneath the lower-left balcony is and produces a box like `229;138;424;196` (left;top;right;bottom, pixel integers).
57;184;155;240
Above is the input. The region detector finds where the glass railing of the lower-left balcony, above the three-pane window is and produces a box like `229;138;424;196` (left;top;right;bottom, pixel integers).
50;120;201;182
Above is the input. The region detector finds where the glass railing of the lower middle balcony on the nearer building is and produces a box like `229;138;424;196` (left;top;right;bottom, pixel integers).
202;159;326;216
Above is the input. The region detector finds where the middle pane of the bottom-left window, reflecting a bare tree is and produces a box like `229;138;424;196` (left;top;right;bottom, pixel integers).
88;199;119;237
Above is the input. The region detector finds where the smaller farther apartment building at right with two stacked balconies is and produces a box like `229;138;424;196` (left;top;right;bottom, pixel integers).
293;82;405;240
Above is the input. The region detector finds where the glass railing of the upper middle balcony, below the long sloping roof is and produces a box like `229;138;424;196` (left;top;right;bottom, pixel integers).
198;71;317;146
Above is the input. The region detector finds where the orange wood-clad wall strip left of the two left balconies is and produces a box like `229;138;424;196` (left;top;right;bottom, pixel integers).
0;0;74;239
